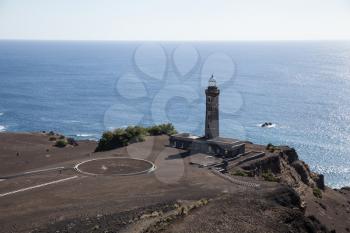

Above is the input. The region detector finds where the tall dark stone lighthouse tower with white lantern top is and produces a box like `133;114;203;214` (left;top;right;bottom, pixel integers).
205;75;220;139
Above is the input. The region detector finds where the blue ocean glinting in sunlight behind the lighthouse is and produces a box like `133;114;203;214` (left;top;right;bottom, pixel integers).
0;41;350;188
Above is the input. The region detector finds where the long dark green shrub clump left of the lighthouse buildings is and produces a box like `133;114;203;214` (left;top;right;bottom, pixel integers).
95;123;177;152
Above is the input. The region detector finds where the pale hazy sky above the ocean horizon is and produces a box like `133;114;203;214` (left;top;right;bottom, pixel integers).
0;0;350;40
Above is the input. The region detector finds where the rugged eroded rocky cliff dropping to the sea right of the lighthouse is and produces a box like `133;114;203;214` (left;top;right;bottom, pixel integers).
228;143;350;232
